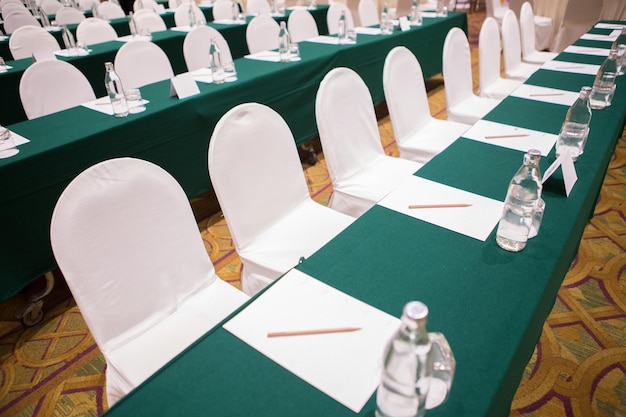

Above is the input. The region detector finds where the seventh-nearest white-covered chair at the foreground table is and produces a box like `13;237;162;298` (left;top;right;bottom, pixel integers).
502;10;541;81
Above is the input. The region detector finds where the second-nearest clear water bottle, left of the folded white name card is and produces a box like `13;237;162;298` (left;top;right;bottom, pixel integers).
496;149;542;252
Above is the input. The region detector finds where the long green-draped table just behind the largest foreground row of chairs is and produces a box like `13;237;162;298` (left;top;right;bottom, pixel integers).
0;13;467;300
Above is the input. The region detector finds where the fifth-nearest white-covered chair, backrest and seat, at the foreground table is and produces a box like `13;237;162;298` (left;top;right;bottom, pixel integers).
443;27;500;125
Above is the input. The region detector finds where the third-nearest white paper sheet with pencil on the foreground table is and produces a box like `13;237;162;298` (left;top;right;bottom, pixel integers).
461;120;557;156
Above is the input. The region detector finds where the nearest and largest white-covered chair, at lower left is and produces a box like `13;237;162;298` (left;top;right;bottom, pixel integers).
50;158;248;407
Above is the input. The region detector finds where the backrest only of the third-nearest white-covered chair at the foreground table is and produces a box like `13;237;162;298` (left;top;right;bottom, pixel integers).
315;67;384;183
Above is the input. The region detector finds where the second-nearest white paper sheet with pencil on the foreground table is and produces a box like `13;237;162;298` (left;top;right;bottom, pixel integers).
378;176;504;242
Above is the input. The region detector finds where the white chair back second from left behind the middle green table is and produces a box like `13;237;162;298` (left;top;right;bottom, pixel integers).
114;40;174;88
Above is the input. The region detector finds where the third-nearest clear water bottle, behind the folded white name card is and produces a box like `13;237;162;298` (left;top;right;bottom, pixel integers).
556;87;591;161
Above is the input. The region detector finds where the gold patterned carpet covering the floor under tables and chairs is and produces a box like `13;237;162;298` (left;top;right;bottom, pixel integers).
0;7;626;417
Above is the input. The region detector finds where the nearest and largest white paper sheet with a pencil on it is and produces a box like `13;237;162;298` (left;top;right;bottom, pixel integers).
224;269;400;413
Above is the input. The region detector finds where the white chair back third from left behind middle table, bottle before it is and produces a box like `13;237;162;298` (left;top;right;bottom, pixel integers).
183;26;233;71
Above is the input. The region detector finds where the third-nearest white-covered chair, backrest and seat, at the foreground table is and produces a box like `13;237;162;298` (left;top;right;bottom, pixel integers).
315;67;422;217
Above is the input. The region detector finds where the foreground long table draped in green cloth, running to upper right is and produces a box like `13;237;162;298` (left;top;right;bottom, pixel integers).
106;22;626;417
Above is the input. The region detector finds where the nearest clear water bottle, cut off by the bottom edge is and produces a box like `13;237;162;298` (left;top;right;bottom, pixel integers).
376;301;433;417
